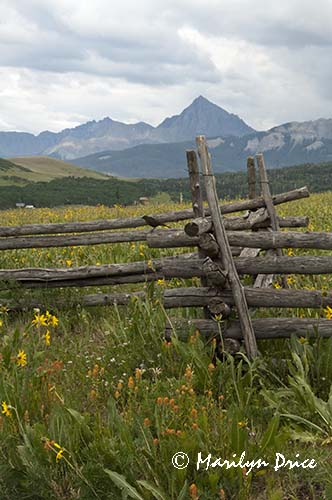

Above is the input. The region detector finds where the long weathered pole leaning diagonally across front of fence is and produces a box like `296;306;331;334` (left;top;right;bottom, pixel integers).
196;135;257;358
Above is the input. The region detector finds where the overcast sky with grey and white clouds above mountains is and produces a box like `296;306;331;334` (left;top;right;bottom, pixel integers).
0;0;332;133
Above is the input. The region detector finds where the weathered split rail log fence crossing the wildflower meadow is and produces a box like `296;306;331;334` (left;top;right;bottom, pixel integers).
0;136;332;357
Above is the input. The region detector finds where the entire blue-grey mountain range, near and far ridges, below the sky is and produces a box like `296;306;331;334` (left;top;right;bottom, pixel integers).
0;96;332;178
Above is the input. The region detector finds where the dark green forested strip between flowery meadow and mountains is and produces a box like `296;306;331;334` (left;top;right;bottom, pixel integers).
0;163;332;208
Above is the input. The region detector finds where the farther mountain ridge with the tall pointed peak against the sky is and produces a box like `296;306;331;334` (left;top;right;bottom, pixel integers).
0;96;254;160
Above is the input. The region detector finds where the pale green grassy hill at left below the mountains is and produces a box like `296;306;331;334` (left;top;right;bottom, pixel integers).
0;156;107;186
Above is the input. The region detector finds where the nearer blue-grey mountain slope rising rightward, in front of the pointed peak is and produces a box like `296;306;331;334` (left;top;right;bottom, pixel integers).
74;119;332;178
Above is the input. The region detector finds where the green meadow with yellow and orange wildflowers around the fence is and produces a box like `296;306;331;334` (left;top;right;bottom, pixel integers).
0;193;332;500
